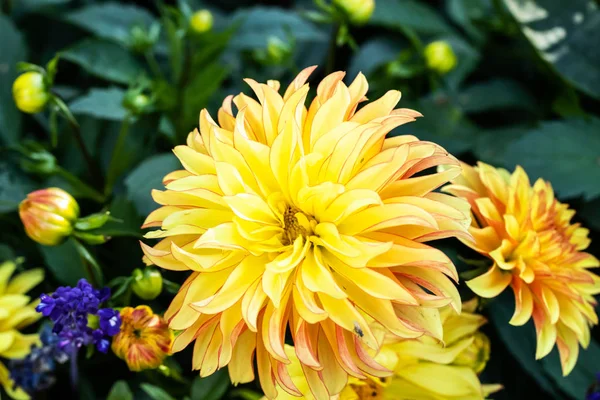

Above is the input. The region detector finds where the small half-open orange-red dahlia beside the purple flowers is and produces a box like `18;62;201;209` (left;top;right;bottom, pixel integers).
112;305;173;371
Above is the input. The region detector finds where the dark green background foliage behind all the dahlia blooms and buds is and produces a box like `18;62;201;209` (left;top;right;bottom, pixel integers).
0;0;600;400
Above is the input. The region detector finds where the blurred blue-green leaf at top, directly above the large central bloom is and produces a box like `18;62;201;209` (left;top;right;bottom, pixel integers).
230;6;327;50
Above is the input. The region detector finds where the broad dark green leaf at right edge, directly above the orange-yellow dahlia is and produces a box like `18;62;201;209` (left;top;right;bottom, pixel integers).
505;117;600;200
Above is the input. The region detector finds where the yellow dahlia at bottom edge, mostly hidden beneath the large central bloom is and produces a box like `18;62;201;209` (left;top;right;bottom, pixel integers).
270;302;501;400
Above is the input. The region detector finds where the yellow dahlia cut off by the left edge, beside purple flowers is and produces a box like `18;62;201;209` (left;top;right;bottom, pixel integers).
0;261;44;400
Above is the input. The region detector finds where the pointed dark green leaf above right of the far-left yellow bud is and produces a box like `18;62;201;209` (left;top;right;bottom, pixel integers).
61;38;144;85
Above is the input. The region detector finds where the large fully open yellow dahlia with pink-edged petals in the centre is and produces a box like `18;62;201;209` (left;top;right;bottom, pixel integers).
142;68;470;398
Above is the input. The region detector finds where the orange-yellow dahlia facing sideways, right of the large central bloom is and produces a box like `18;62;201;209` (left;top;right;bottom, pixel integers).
444;162;600;375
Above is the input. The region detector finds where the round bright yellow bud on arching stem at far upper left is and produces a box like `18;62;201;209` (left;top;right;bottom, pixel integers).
13;71;50;114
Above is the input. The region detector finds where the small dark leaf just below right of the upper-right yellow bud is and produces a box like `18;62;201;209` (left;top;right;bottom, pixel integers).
458;79;537;113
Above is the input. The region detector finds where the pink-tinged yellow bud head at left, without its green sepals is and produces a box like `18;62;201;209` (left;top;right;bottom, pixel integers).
19;188;79;246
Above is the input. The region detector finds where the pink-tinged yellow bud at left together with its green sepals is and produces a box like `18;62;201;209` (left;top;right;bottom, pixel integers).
19;188;111;246
